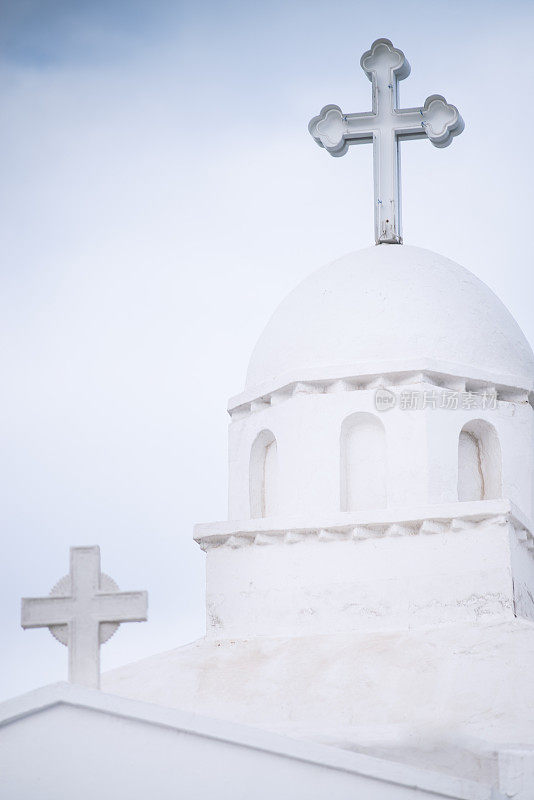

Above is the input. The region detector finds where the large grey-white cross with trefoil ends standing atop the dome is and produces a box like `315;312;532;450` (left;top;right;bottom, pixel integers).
308;39;464;244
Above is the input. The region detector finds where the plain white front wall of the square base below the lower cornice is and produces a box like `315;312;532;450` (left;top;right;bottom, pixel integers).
206;522;516;639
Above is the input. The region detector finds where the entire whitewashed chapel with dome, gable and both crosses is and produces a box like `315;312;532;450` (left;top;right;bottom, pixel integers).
0;39;534;800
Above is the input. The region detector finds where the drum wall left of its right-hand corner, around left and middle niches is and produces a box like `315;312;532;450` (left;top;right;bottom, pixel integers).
229;391;426;519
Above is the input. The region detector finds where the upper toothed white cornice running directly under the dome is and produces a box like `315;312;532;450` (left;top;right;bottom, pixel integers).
228;370;534;421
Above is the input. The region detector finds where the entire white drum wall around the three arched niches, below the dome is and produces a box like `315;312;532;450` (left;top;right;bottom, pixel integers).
229;390;534;520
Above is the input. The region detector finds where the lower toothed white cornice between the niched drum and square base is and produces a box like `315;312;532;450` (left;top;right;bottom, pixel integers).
194;500;534;551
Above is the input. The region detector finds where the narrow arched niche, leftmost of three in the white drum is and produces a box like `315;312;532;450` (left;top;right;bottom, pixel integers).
249;430;278;518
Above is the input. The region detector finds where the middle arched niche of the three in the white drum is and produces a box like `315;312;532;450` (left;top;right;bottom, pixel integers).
340;412;387;511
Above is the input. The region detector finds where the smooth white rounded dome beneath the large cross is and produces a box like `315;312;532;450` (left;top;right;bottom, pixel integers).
245;245;534;395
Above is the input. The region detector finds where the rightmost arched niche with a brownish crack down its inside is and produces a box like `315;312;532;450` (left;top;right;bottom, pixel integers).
458;419;502;501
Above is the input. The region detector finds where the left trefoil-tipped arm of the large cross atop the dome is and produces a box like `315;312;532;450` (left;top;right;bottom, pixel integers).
308;105;376;156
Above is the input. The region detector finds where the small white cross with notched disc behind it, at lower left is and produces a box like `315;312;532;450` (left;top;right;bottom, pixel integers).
21;546;148;689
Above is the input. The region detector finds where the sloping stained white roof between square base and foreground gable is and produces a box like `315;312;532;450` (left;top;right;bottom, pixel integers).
103;615;534;788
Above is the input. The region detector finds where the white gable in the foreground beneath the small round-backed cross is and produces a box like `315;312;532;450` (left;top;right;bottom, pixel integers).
0;683;500;800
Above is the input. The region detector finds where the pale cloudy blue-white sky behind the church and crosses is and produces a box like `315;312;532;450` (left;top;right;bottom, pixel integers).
0;0;534;697
